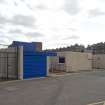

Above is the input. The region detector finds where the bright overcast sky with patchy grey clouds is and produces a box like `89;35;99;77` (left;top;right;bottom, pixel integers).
0;0;105;48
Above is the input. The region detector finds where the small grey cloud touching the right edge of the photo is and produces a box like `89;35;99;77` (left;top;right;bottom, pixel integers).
88;8;105;17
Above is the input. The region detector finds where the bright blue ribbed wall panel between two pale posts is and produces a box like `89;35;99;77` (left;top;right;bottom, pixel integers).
23;53;47;78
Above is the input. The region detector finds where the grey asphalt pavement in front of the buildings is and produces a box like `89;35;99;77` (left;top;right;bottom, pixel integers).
0;71;105;105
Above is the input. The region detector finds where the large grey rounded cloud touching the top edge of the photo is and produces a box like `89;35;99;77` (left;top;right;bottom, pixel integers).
64;0;80;15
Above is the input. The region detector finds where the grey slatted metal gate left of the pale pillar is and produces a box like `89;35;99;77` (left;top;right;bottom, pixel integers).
0;44;18;81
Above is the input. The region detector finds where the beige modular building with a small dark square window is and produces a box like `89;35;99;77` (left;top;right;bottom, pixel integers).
49;51;92;72
